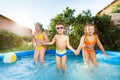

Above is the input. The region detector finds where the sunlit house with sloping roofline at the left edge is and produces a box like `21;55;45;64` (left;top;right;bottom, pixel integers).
0;14;32;37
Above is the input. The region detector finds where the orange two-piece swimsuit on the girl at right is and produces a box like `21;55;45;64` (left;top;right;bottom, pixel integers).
84;35;97;53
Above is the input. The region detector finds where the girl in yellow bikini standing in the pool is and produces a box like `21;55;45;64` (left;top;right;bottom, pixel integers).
32;23;49;63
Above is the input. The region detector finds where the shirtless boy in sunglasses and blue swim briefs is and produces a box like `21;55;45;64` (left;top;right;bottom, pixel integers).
43;23;75;73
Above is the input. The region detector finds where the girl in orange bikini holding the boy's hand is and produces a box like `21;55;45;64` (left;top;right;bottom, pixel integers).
76;24;108;67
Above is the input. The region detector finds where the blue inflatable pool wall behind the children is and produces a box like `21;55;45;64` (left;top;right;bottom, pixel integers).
0;50;120;65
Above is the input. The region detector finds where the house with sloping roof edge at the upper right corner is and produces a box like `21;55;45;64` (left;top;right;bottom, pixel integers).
97;0;120;29
